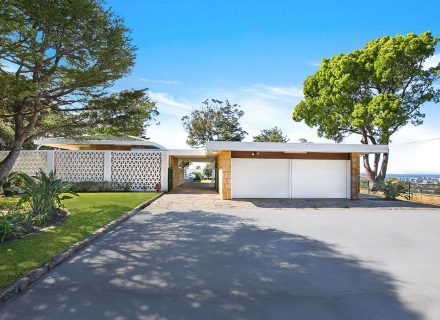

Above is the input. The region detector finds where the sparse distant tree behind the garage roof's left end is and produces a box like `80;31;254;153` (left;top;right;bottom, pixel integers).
182;99;247;148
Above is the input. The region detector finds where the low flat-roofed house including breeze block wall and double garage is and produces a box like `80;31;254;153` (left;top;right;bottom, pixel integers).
0;138;388;199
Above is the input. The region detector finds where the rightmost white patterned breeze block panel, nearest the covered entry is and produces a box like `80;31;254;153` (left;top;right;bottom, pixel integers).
111;151;162;191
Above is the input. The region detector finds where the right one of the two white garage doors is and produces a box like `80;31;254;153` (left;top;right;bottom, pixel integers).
292;160;350;198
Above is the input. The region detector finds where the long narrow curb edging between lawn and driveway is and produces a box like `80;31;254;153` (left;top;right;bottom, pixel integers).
0;192;164;304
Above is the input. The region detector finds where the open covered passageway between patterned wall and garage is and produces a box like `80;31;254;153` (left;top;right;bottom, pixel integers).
168;156;218;194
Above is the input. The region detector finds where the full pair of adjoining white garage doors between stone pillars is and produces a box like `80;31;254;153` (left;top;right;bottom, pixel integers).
231;158;350;198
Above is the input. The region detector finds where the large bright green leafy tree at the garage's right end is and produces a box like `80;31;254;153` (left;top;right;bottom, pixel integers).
293;32;440;183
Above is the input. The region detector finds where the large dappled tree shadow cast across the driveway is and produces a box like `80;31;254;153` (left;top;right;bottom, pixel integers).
0;211;421;320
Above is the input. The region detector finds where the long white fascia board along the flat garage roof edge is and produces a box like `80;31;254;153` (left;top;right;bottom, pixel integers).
206;141;388;153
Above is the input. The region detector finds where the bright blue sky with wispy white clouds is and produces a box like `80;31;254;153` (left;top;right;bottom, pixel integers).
106;0;440;173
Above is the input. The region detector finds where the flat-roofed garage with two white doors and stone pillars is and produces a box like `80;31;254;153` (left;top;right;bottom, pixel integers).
206;141;388;199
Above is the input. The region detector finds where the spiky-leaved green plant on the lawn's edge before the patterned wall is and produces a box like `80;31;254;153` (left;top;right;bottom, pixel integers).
13;169;78;223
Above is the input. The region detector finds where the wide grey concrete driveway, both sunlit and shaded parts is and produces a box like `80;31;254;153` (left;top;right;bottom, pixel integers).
0;194;440;320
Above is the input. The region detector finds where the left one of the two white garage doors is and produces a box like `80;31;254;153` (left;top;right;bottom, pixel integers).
231;158;290;198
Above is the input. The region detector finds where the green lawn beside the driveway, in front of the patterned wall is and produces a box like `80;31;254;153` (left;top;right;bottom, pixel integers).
0;192;157;288
